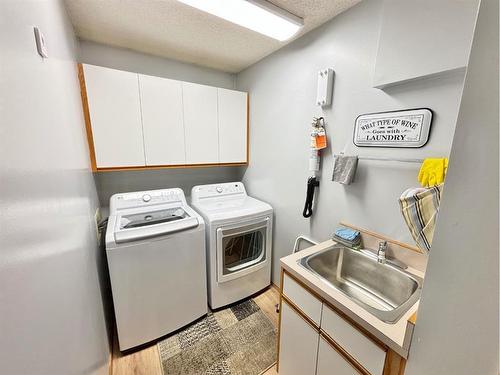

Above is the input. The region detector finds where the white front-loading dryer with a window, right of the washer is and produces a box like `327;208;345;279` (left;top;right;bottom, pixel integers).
191;182;273;309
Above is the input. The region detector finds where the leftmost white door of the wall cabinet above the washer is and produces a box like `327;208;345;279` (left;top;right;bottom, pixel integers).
84;65;145;168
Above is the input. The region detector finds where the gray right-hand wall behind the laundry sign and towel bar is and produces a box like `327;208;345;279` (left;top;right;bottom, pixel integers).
237;0;470;282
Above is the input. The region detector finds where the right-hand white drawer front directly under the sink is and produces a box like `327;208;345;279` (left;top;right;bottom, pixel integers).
321;306;386;375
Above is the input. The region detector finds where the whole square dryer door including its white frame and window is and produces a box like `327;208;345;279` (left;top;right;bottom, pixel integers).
217;217;271;283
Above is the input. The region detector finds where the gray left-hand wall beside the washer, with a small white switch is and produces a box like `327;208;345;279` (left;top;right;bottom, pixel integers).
0;0;109;375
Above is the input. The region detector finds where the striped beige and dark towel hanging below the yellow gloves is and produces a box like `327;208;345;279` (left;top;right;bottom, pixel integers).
399;184;443;252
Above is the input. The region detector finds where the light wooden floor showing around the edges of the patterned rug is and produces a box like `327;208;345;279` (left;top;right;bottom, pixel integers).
110;287;279;375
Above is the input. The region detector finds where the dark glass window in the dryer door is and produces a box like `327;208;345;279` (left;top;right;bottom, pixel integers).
222;227;266;275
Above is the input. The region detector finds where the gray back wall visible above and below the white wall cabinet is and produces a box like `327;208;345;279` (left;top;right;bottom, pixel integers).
79;41;244;207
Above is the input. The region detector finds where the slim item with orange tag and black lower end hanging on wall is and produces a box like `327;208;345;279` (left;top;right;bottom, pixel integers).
302;117;327;218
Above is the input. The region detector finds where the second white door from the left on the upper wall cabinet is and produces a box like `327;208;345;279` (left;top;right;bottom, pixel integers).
139;74;186;165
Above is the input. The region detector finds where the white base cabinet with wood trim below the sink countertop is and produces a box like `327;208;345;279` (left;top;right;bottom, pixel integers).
278;270;406;375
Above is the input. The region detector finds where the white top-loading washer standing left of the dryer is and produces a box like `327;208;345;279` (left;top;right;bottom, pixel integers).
106;189;208;350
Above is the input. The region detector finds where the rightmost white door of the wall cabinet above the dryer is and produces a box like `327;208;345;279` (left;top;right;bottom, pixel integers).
217;89;247;163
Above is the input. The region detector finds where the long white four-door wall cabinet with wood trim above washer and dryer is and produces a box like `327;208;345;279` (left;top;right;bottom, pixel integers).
78;64;248;171
